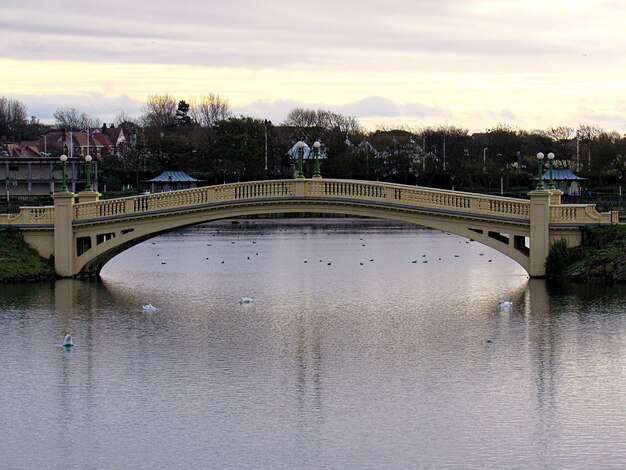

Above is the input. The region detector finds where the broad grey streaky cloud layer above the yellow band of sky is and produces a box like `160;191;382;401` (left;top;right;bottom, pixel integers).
0;0;617;70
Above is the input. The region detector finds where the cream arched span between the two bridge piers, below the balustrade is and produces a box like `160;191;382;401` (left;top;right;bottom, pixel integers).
74;199;530;276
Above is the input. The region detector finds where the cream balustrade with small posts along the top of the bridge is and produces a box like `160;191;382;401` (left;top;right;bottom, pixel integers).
0;179;612;224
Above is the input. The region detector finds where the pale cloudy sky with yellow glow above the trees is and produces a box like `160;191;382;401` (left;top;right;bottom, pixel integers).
0;0;626;134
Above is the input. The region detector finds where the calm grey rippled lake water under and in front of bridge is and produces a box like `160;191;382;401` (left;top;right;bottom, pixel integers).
0;219;626;469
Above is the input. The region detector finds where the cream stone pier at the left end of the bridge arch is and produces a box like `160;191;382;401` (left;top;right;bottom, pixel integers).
52;192;76;277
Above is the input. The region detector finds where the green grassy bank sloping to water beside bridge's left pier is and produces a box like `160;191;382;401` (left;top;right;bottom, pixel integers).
0;227;55;282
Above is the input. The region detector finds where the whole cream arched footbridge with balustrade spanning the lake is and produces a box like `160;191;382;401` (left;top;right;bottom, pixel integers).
0;178;618;277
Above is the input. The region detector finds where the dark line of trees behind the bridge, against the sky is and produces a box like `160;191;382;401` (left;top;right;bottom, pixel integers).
0;93;626;191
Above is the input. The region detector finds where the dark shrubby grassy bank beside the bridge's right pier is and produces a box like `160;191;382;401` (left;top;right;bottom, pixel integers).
546;225;626;283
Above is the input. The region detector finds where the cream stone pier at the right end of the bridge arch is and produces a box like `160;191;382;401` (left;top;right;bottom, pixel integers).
528;189;563;277
